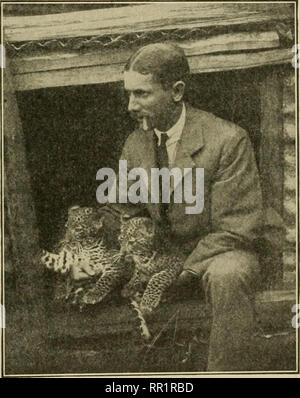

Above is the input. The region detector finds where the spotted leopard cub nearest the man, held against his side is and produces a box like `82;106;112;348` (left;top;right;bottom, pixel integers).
119;218;186;315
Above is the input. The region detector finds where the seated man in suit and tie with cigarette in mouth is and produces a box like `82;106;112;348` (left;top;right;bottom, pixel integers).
72;44;262;371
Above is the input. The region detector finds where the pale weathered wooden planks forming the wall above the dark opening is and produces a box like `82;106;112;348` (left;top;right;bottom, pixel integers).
4;2;294;90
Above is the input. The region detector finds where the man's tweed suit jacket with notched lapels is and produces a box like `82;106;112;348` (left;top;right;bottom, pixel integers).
110;105;263;275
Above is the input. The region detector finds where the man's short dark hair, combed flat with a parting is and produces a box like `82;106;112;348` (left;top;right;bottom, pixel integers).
125;43;190;89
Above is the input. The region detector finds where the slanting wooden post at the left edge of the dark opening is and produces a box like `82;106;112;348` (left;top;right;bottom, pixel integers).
3;57;43;301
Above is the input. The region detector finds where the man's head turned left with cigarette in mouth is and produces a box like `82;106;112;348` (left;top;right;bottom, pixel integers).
124;43;189;131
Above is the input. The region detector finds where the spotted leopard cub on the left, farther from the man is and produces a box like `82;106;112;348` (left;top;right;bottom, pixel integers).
41;206;124;303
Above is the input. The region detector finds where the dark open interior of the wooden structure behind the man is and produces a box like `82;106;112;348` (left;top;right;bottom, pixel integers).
17;69;262;248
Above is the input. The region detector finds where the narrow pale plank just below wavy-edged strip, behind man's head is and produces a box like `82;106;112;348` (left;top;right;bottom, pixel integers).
12;31;279;74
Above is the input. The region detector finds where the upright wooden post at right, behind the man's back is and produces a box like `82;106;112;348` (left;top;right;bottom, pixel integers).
260;68;284;288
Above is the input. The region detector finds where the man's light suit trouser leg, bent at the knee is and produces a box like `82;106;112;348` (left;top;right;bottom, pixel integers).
201;250;260;371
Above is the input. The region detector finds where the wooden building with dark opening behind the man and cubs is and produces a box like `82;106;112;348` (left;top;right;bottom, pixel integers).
3;2;297;373
